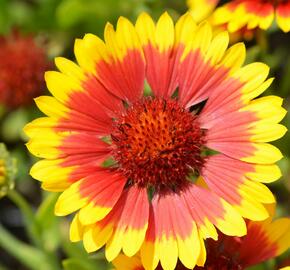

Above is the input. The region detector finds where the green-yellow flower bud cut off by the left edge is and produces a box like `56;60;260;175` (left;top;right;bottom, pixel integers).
0;143;16;198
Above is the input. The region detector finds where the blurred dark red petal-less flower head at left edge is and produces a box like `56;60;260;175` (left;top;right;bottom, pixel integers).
0;31;49;109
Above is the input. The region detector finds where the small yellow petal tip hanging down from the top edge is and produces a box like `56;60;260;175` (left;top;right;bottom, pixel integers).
187;0;218;22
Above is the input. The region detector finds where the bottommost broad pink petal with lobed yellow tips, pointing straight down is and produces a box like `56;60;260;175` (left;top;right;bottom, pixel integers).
141;192;200;270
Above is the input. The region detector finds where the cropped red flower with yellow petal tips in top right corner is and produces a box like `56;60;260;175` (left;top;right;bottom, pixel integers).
212;0;290;32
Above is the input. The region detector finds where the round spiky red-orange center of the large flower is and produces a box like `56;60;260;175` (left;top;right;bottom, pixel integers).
111;98;204;189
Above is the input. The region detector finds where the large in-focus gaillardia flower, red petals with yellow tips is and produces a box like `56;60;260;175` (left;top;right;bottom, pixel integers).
25;13;286;270
